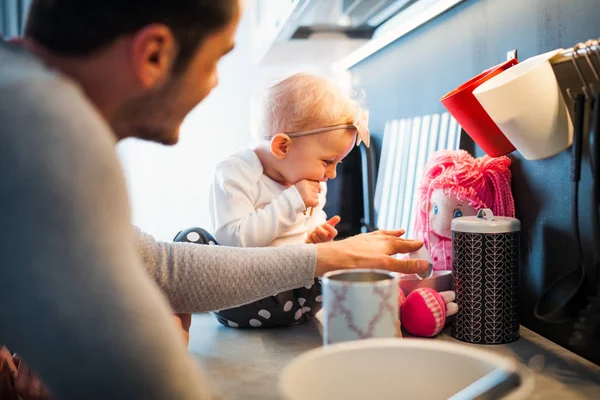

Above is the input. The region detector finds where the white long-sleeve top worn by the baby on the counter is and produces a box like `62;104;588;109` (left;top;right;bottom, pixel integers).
210;147;327;247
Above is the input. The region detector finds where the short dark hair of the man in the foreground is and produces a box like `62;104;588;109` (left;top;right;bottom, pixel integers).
25;0;238;71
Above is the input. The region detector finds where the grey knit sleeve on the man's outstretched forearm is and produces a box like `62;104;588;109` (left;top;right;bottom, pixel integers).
137;230;316;312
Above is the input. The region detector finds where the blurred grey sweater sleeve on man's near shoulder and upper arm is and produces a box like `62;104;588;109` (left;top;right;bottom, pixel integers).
0;79;223;400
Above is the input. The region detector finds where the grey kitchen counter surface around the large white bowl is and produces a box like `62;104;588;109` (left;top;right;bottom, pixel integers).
189;314;600;400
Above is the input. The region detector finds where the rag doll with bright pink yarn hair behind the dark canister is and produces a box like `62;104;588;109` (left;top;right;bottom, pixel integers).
400;150;515;336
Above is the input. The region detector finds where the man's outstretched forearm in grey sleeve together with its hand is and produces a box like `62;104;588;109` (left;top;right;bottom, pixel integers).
137;225;428;313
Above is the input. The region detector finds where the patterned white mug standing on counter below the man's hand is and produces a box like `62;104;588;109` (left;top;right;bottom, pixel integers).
322;269;401;345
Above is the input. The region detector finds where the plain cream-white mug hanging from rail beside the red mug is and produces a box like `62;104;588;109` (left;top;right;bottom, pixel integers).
473;49;573;160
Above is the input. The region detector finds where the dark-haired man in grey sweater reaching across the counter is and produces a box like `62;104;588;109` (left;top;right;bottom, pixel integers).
0;0;427;400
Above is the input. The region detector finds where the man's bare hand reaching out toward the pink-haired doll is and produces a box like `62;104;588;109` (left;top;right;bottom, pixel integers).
315;230;429;276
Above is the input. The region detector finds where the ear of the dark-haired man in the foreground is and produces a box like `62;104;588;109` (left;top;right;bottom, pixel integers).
131;24;177;89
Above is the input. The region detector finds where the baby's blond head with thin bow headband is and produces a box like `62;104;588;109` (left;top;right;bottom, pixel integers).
264;74;366;184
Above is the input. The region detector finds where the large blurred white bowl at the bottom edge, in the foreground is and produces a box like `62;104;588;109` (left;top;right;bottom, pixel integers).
279;338;533;400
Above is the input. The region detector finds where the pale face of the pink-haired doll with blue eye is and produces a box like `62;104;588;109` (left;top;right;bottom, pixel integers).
429;189;477;239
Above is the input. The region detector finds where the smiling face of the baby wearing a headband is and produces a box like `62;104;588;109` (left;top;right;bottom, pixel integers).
280;129;356;185
